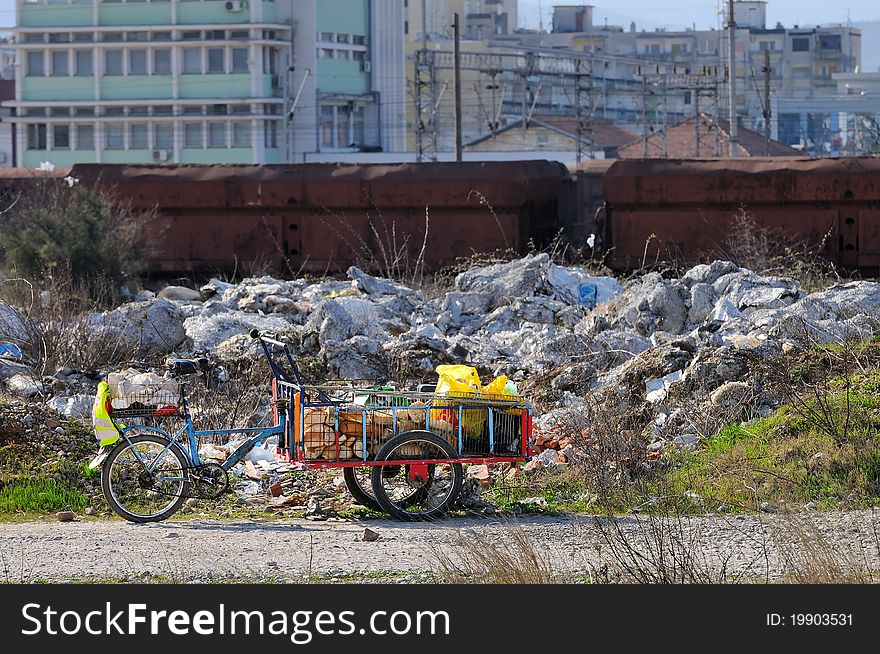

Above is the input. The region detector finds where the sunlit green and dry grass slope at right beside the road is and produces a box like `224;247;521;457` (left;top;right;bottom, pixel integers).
653;392;880;511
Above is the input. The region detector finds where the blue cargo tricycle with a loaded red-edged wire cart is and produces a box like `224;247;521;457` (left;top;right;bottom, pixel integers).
99;330;532;523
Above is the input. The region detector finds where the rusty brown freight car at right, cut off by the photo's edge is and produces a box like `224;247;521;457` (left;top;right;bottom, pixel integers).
596;157;880;274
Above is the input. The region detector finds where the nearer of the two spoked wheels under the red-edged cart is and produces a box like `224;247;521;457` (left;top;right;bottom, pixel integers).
371;431;464;521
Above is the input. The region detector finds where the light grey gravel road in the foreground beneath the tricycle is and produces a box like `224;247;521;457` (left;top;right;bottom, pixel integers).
0;511;880;582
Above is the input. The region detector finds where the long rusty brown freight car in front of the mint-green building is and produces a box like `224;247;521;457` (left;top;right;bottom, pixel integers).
71;161;566;274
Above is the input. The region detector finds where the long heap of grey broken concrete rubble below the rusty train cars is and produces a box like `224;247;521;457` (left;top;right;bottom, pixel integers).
0;254;880;486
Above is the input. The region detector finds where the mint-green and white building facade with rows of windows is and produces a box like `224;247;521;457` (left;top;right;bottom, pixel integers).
6;0;403;167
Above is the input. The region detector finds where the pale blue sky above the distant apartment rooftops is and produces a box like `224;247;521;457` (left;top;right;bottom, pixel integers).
520;0;880;29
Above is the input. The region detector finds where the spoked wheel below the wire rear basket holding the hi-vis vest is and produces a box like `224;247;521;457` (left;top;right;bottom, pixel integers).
101;433;190;522
